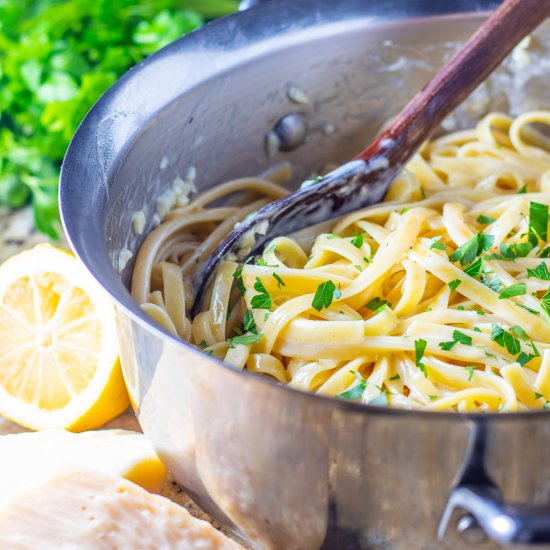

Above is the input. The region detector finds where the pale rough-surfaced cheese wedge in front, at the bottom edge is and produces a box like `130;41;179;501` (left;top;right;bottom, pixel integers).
0;469;241;550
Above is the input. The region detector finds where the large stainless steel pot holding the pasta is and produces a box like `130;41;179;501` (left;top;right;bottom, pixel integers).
60;0;550;549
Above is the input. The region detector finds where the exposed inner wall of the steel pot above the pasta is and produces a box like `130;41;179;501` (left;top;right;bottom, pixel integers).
104;16;550;283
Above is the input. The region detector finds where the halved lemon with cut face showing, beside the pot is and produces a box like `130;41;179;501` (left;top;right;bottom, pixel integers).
0;244;129;431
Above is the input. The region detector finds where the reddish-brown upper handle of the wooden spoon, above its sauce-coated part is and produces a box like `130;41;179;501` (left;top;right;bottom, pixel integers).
356;0;550;165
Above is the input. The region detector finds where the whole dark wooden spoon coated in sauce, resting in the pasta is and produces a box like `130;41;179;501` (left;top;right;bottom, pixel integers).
192;0;550;315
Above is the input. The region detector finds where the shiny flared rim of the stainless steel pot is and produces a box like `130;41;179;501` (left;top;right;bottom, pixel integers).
59;0;548;422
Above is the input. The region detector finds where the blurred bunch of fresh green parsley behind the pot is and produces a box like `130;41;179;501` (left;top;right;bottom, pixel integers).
0;0;238;238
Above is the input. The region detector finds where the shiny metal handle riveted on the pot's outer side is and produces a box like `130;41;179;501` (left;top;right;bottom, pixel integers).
437;422;550;544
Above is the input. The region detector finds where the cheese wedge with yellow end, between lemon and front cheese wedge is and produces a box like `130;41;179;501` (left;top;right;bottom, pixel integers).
0;430;166;508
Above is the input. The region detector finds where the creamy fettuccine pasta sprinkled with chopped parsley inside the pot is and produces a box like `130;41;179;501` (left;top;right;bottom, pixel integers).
132;111;550;412
